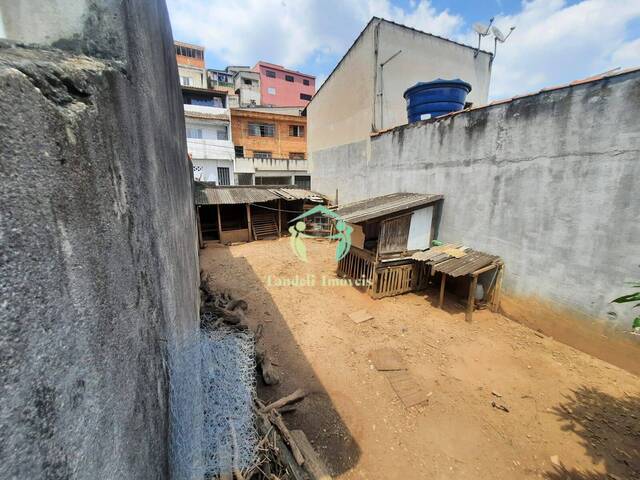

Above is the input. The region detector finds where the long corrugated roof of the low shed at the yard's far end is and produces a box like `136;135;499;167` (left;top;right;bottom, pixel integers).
194;182;324;205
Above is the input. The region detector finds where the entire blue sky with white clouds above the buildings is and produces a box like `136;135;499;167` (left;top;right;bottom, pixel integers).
167;0;640;99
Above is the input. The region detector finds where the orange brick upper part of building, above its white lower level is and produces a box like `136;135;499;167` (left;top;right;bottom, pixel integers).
231;108;307;160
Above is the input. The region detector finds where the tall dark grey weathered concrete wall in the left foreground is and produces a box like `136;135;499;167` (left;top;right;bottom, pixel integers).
0;0;199;479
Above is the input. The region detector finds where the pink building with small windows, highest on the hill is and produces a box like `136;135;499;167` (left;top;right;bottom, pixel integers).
253;61;316;107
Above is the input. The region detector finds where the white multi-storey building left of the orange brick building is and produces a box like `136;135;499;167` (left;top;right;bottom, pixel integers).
183;87;235;185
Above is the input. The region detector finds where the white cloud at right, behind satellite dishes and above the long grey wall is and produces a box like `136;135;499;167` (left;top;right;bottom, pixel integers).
478;0;640;98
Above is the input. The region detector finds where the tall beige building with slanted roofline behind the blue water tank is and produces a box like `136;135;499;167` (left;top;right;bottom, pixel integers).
306;17;493;154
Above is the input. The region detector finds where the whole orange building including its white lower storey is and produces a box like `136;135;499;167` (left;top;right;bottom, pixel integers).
231;108;311;188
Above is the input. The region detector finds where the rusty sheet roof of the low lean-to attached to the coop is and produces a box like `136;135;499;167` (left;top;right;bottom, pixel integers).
411;244;501;277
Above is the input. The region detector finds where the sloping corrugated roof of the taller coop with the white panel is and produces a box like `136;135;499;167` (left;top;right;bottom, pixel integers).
335;193;443;223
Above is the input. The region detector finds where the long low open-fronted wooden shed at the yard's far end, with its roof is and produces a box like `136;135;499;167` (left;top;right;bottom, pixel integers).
194;182;325;248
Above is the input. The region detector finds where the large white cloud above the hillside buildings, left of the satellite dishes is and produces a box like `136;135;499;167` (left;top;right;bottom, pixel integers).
168;0;463;73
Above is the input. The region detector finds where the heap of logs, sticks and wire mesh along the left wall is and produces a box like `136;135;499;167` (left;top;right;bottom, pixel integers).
200;278;331;480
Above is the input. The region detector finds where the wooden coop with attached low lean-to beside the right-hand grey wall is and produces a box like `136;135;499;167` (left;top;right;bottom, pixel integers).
335;193;504;321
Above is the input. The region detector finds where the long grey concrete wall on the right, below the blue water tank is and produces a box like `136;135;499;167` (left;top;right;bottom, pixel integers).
312;72;640;372
